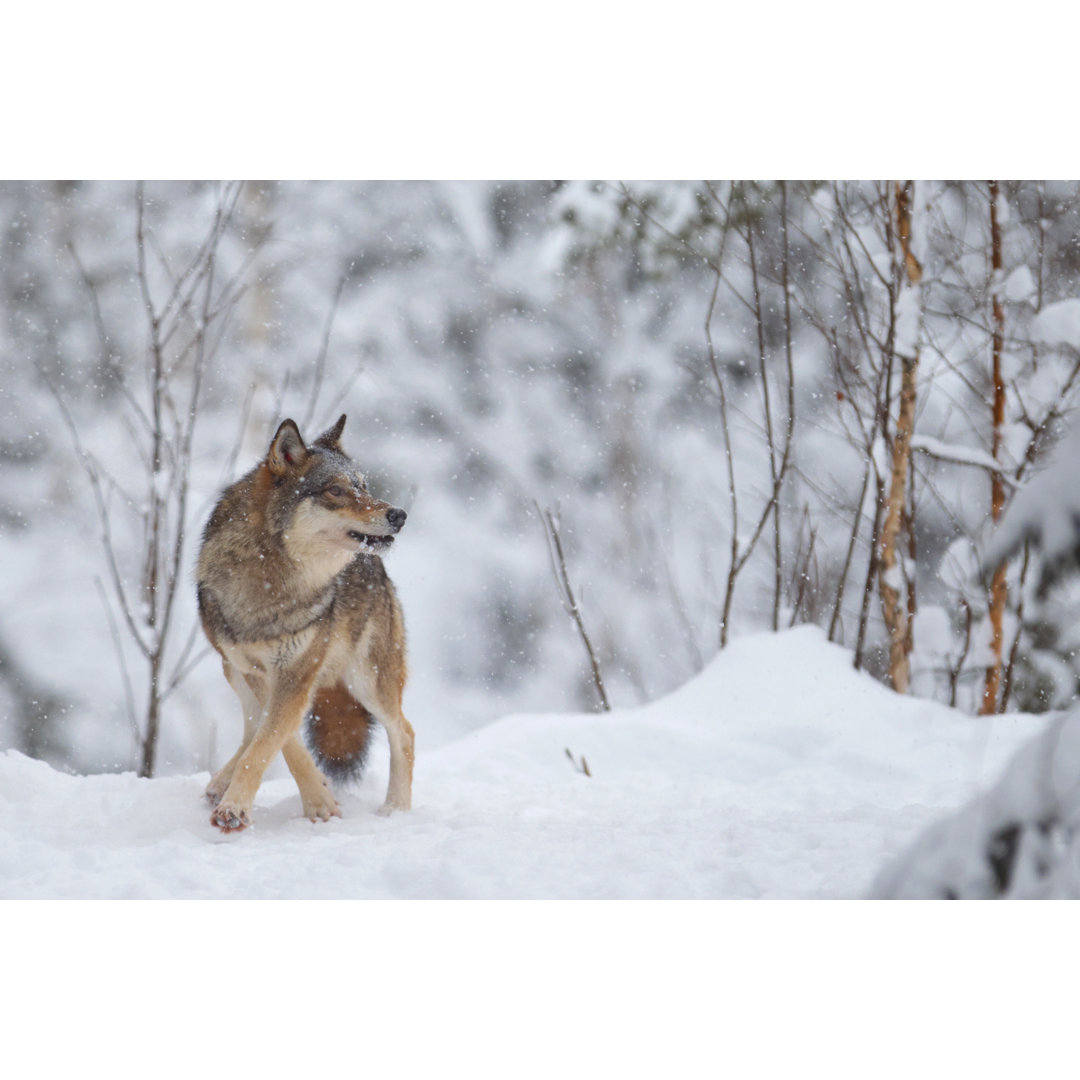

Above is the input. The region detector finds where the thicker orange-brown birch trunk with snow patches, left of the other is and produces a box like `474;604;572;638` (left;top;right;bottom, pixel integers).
878;180;922;693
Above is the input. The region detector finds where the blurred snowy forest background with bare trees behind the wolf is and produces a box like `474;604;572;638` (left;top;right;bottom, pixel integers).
0;181;1080;773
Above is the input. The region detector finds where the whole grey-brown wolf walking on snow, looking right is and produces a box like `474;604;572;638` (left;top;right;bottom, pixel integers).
198;416;414;833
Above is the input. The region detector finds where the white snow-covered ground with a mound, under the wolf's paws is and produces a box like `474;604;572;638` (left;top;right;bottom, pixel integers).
0;627;1044;900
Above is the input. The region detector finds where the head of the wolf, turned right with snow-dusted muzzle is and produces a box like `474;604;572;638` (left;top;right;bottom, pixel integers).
264;416;406;567
